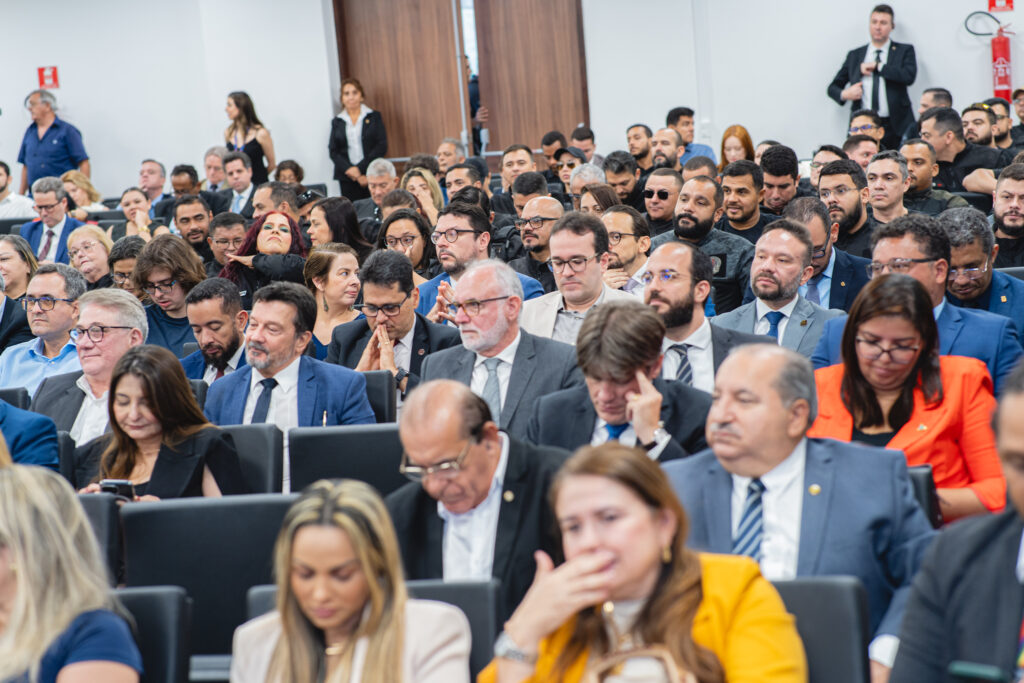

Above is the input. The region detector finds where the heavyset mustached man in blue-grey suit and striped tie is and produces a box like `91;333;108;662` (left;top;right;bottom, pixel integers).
665;344;934;669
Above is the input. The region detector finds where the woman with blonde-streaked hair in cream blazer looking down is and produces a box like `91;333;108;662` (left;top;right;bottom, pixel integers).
230;479;470;683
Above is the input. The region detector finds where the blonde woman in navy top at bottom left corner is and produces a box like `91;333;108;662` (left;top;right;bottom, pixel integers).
0;465;142;683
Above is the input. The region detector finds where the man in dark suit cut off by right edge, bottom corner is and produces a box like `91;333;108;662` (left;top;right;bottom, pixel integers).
892;368;1024;683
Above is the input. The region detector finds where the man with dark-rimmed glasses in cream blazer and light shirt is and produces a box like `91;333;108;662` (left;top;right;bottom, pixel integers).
520;211;636;344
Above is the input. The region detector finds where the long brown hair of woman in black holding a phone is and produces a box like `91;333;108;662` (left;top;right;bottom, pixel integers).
98;344;212;479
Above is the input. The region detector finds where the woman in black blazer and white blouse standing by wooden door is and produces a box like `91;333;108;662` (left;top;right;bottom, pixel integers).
328;78;387;202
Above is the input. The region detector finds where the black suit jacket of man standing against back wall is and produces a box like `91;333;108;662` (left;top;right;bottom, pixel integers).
828;41;918;137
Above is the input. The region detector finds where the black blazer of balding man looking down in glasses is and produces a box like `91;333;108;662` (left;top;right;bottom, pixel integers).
387;438;569;622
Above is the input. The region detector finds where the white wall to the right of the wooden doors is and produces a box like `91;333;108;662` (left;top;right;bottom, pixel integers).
583;0;1024;157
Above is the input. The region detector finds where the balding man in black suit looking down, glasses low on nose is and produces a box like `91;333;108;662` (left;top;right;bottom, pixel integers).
387;380;569;621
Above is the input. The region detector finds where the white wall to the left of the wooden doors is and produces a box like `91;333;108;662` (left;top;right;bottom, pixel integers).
0;0;339;197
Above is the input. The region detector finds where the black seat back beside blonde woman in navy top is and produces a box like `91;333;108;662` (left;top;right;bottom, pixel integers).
114;586;191;683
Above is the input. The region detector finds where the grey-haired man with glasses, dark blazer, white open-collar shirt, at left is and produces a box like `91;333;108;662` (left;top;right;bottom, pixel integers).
32;289;148;446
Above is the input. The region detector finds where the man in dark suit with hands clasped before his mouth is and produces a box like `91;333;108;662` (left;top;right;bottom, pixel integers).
327;250;459;404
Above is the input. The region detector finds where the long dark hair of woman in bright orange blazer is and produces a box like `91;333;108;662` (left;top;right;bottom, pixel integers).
841;273;950;431
